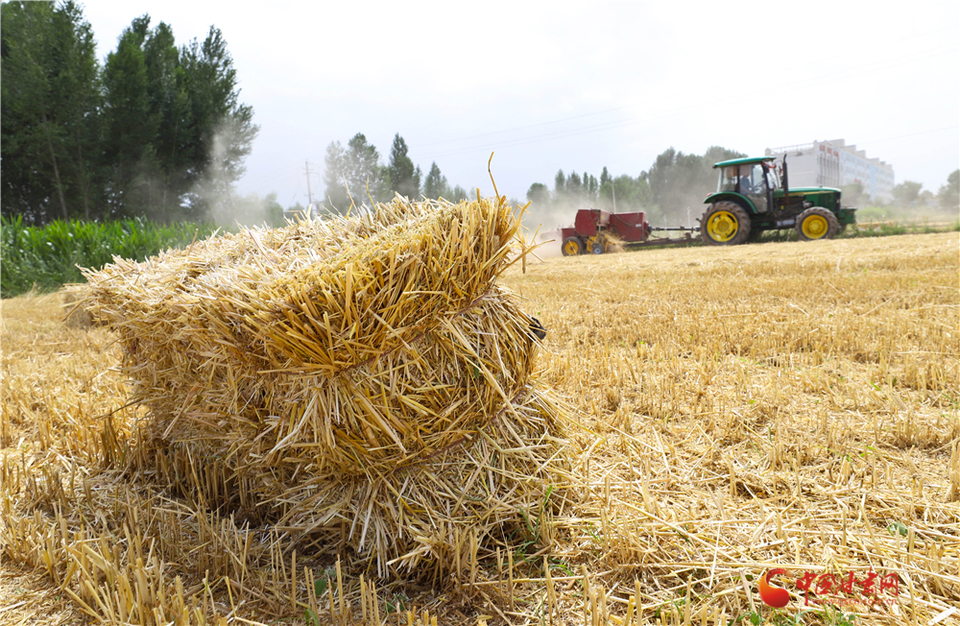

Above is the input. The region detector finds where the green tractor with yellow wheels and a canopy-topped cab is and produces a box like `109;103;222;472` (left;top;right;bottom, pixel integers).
700;156;856;246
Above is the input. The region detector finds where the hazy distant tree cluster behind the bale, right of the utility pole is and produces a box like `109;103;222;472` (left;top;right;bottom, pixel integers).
323;133;467;213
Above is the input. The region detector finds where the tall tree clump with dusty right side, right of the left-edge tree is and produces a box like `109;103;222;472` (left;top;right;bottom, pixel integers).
103;15;259;220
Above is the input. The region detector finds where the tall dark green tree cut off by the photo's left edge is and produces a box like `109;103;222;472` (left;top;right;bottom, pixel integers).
0;0;100;224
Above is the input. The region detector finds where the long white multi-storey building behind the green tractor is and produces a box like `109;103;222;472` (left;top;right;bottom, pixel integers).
766;139;894;202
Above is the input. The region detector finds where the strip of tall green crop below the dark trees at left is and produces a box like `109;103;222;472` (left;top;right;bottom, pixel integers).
0;216;215;298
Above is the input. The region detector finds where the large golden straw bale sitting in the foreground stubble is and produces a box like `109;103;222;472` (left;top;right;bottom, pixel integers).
87;198;566;567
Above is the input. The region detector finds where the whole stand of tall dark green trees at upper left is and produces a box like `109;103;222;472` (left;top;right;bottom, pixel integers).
0;0;259;225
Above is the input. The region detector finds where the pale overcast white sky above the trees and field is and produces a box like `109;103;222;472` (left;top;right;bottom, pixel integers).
84;0;960;207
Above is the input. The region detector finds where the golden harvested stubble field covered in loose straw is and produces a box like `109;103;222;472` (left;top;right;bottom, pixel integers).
0;233;960;625
